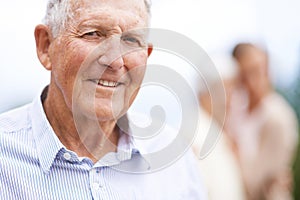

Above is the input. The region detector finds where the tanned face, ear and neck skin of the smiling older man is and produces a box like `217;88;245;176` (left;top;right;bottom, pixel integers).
35;0;152;162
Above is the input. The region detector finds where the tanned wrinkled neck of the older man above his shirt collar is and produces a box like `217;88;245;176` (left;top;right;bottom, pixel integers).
43;86;119;162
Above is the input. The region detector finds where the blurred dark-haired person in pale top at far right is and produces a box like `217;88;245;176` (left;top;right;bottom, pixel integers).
225;43;298;200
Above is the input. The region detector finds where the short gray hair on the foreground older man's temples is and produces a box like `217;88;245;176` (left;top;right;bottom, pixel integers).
43;0;151;37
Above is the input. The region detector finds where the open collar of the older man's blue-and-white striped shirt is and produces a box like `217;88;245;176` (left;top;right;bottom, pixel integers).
30;88;150;173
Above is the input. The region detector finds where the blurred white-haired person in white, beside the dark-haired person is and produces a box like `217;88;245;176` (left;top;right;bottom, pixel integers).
193;55;246;200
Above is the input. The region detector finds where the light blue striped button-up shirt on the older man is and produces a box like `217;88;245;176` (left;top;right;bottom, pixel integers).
0;93;206;200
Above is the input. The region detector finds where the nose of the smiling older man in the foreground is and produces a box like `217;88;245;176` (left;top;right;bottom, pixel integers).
98;36;124;70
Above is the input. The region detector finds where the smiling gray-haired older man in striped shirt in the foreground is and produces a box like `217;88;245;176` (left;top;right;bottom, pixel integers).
0;0;205;200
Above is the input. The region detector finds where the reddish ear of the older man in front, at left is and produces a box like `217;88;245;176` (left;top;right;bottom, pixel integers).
34;24;52;70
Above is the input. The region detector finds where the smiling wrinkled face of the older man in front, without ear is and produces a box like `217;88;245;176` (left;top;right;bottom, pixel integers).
49;0;149;120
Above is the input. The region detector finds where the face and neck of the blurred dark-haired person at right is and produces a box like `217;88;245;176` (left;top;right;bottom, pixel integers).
237;46;271;111
